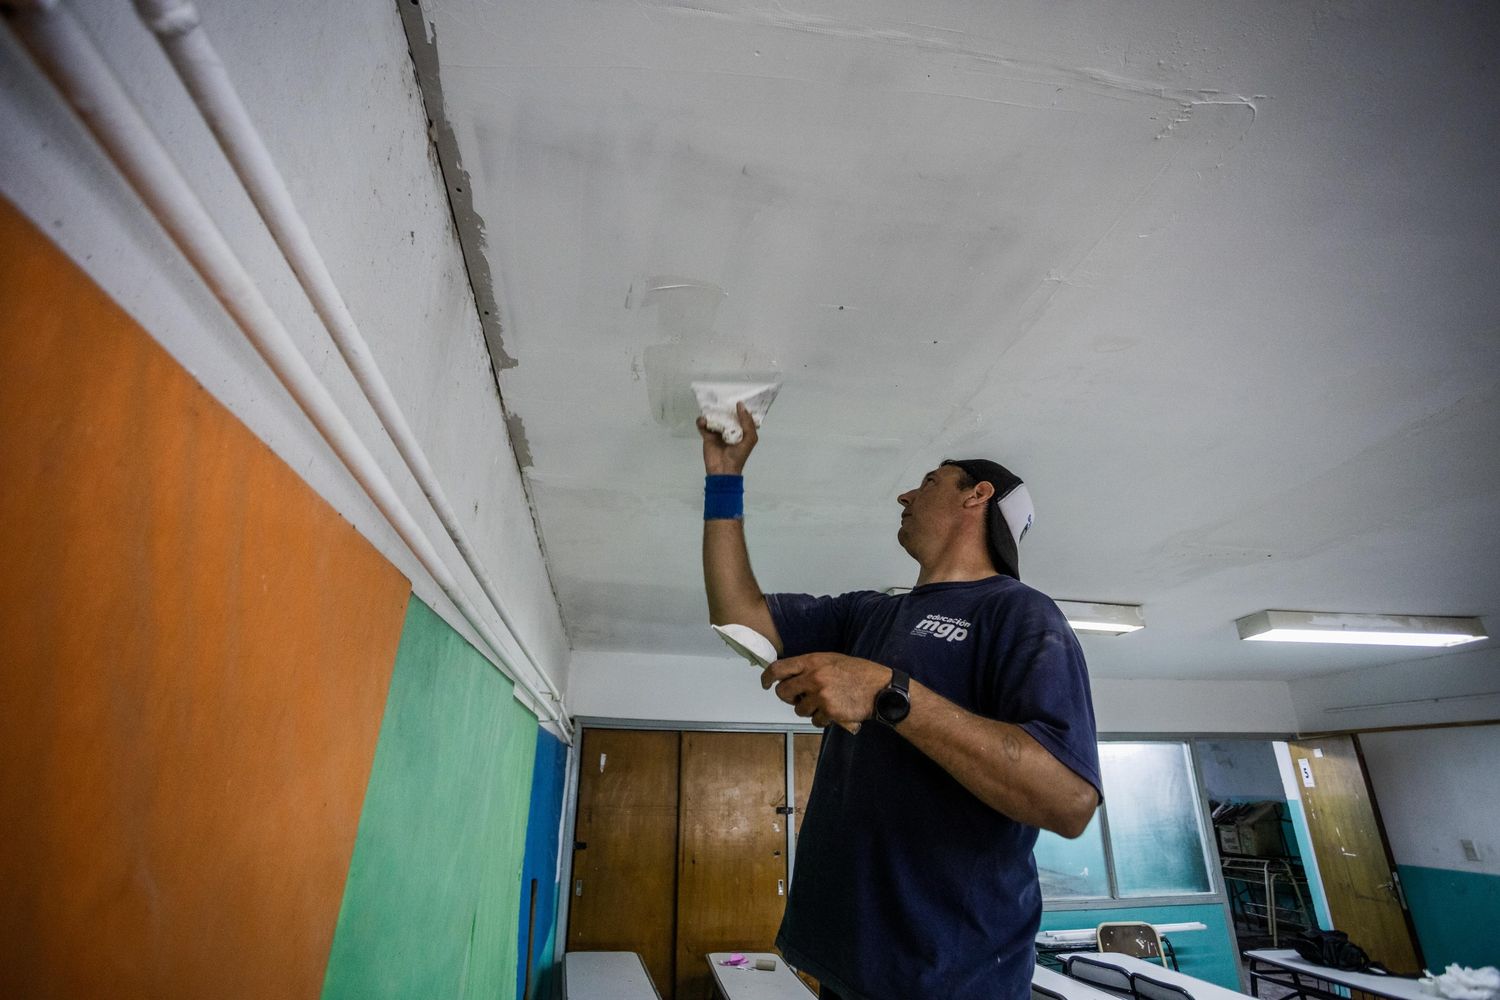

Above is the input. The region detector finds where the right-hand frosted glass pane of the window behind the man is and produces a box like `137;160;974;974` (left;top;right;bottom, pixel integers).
1100;744;1212;897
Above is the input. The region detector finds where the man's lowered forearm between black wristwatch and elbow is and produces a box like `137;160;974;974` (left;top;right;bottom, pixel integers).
897;681;1098;838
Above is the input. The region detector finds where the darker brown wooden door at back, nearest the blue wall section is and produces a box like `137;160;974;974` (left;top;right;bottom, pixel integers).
567;729;678;997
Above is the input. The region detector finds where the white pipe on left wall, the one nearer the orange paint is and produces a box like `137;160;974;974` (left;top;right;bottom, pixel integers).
0;0;570;732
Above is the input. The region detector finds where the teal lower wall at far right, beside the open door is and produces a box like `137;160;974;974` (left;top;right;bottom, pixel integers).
1397;865;1500;972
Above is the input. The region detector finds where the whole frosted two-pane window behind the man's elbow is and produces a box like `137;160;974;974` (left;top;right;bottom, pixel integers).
1035;742;1214;901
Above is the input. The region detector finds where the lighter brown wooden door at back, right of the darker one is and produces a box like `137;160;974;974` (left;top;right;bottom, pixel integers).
677;733;788;1000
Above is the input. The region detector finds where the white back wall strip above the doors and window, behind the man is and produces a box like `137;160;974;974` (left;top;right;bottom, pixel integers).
567;649;1296;733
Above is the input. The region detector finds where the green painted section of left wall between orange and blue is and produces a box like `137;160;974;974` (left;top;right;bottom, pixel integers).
323;597;537;1000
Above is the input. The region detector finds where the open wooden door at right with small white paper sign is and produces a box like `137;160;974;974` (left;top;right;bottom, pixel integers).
1289;736;1421;973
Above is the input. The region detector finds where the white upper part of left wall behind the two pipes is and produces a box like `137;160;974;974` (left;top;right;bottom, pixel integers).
0;0;569;687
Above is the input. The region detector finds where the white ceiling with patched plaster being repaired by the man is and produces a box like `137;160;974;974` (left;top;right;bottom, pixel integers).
408;0;1500;678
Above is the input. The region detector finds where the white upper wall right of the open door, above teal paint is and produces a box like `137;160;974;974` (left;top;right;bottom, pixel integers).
1359;726;1500;876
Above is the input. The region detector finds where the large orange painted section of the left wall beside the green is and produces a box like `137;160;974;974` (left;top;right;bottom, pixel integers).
0;201;410;1000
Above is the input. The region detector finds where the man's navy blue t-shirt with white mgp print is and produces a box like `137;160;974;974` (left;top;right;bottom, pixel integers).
767;576;1100;1000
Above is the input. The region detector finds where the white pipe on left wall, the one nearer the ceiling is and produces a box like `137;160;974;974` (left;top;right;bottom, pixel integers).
124;0;563;719
